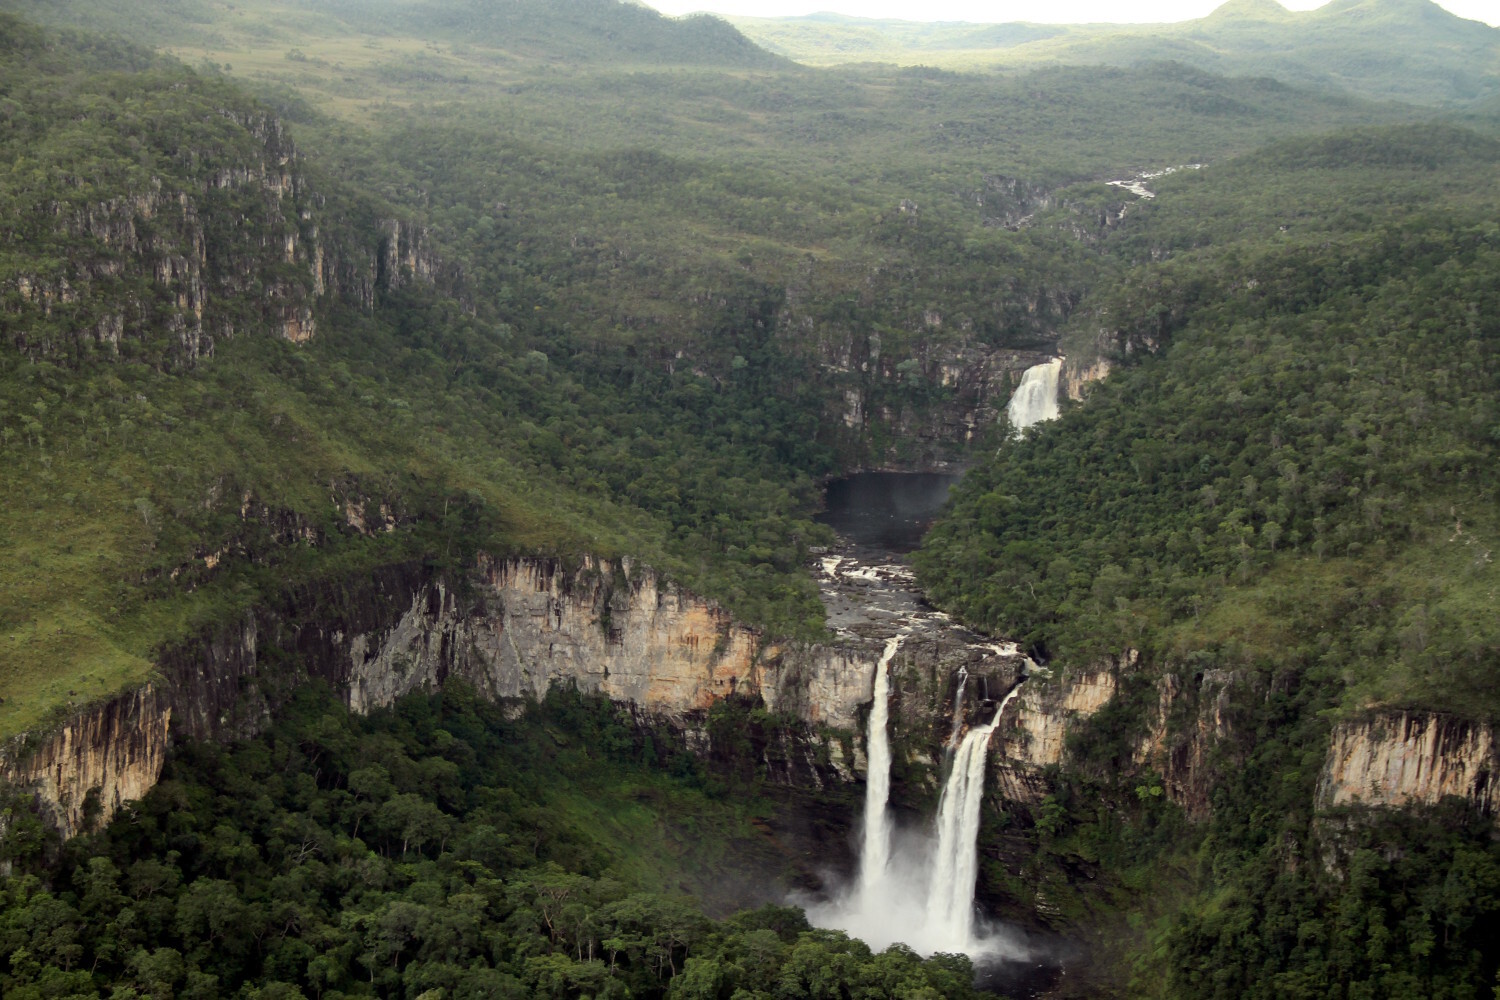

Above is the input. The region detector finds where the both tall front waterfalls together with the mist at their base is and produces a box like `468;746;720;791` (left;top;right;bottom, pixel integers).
807;628;1020;958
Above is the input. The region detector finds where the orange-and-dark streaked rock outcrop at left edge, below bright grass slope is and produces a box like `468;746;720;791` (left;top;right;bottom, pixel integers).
0;685;171;838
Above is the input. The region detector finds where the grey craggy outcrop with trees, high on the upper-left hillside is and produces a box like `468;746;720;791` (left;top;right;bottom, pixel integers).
0;96;447;364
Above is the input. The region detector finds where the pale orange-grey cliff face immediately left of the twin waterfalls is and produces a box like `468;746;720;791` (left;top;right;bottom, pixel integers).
347;559;873;729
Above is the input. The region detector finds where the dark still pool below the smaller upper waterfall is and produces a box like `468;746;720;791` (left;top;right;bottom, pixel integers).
818;472;960;553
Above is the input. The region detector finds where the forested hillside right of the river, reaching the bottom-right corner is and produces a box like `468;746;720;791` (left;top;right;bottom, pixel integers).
918;126;1500;997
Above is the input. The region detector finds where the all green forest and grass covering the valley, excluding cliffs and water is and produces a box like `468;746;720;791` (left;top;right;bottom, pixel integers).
0;0;1500;1000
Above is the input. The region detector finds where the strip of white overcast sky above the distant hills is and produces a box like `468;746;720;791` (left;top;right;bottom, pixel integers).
648;0;1500;27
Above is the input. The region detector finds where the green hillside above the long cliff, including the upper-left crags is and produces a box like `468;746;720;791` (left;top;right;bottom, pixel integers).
0;4;1412;743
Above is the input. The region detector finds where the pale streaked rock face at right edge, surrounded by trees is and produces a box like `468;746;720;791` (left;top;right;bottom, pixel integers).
1317;712;1500;819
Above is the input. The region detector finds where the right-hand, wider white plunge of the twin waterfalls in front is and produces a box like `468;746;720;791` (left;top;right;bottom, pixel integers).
927;684;1022;951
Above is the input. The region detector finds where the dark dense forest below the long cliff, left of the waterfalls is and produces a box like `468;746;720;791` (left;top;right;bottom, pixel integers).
0;685;975;1000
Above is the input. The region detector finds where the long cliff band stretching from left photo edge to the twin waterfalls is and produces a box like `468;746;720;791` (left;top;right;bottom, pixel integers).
5;558;878;835
